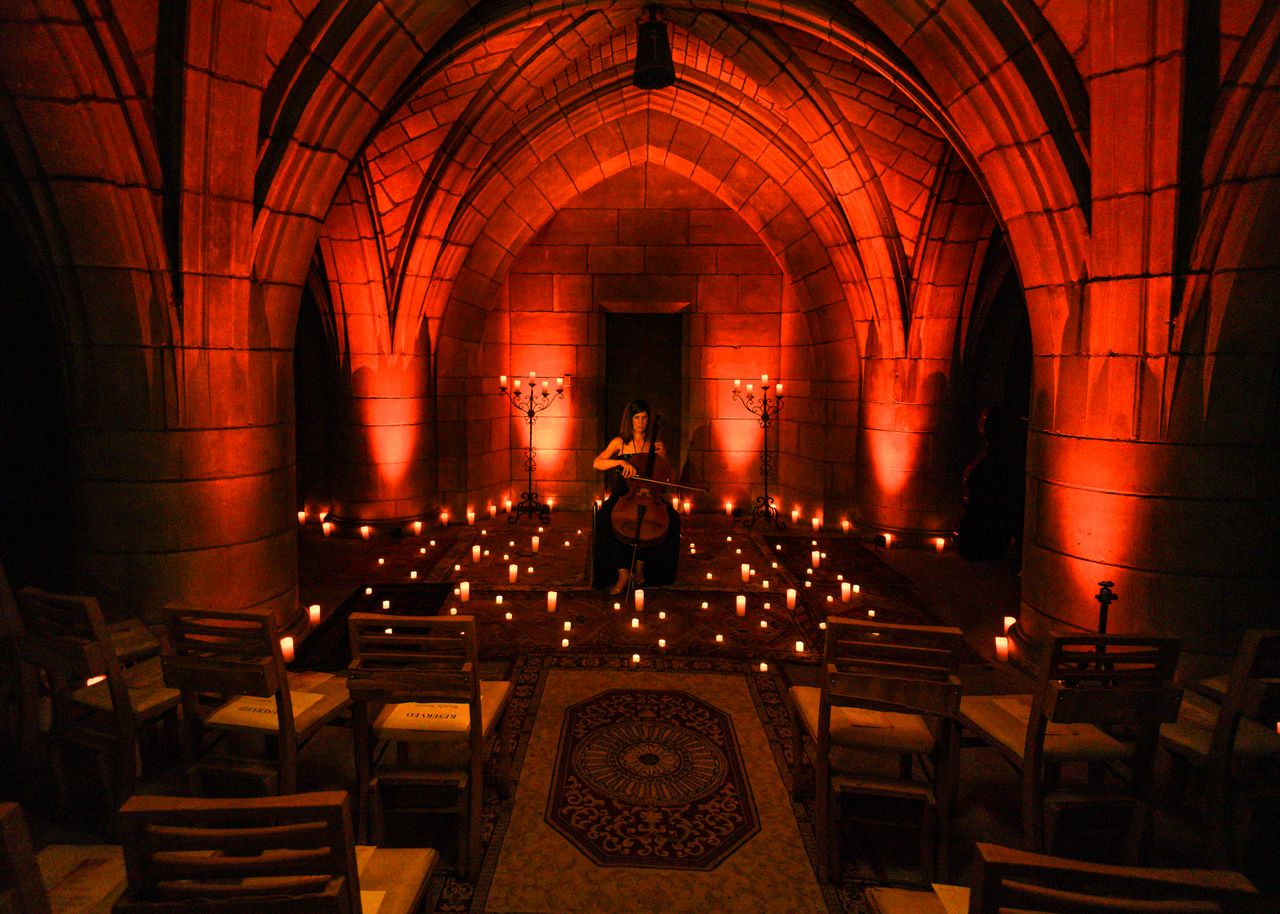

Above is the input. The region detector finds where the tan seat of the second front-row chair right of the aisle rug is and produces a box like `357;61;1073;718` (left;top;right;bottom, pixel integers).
960;695;1133;762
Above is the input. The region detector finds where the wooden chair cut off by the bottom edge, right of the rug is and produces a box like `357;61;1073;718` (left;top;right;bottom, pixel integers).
867;842;1261;914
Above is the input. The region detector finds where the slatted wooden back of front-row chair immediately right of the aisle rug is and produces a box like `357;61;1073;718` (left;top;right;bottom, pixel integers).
819;617;964;730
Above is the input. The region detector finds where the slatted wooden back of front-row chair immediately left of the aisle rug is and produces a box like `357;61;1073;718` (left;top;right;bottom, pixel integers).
347;613;484;757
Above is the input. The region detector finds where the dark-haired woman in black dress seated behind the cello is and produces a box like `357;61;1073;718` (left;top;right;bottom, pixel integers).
591;399;680;594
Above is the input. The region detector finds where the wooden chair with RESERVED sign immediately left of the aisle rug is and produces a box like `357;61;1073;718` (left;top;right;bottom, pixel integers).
348;613;512;878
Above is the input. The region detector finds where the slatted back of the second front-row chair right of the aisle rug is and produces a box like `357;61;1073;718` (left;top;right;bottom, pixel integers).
1024;635;1183;771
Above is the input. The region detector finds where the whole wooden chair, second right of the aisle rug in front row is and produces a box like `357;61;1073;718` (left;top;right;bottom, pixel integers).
960;635;1181;860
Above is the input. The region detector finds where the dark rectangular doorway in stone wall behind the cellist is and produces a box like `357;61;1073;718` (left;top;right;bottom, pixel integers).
600;311;685;477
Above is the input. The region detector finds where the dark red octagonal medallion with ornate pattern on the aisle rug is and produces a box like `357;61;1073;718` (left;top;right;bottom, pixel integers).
547;689;760;870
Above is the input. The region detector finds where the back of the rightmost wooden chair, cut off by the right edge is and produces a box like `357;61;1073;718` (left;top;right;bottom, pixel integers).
1208;629;1280;783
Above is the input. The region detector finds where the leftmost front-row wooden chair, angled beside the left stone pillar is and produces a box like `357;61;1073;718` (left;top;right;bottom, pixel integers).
18;588;178;812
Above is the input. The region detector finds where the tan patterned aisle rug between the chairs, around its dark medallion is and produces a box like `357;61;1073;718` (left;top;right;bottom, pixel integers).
424;654;864;914
